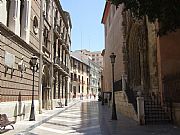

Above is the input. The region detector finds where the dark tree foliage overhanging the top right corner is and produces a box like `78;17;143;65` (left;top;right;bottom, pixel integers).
110;0;180;36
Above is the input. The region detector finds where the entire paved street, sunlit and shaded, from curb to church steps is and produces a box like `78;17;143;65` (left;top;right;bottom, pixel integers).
11;100;180;135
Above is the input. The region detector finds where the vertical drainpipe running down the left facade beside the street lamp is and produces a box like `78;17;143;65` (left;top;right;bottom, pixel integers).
39;0;44;114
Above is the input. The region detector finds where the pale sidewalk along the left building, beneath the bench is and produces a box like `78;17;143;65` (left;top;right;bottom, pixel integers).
0;99;79;135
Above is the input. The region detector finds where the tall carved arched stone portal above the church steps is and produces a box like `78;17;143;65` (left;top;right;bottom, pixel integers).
128;21;149;94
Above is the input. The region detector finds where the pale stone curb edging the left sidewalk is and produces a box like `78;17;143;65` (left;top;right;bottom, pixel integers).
14;100;80;135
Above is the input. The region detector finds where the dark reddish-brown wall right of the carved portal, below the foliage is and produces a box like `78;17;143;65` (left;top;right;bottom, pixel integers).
157;30;180;95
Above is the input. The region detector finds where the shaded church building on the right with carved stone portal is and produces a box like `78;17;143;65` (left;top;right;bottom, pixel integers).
102;1;180;125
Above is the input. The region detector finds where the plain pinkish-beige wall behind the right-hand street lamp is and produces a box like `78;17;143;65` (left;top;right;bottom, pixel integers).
104;7;124;91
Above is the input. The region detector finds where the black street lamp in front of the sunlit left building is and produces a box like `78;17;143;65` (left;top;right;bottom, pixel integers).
29;55;38;121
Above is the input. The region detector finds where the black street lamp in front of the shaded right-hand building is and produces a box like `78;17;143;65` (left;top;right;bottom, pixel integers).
110;53;117;120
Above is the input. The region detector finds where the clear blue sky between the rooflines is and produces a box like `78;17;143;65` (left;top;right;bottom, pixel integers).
60;0;105;51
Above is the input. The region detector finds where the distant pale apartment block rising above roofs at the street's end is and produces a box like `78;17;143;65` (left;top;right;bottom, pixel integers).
75;49;103;67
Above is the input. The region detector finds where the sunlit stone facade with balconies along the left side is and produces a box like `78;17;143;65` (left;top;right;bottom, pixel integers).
0;0;72;120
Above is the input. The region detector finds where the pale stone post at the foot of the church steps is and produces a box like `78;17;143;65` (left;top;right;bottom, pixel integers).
137;97;145;125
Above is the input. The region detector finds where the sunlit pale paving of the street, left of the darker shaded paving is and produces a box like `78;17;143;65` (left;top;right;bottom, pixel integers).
23;101;101;135
